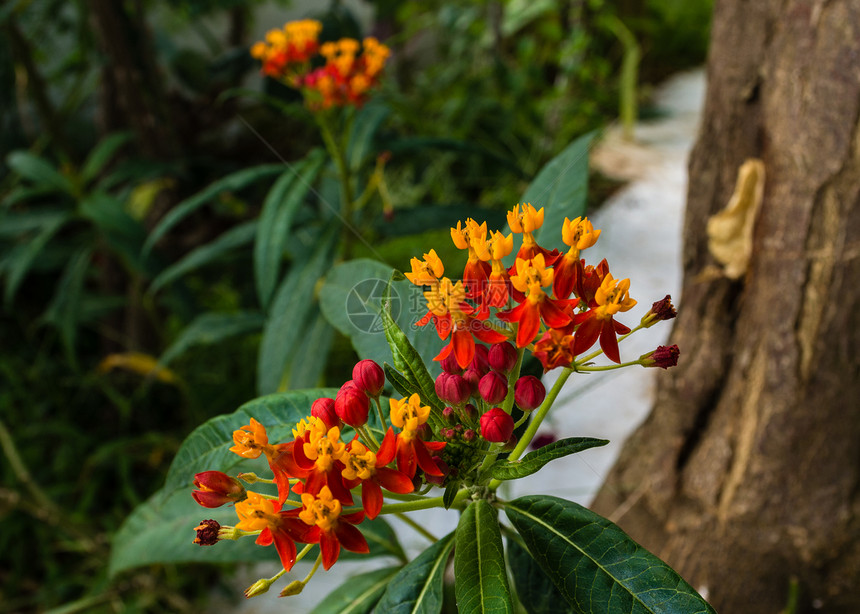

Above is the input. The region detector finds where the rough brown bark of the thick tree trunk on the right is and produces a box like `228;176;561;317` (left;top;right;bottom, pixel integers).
593;0;860;614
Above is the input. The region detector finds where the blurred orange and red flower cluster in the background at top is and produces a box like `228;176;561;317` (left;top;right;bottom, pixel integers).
251;19;390;109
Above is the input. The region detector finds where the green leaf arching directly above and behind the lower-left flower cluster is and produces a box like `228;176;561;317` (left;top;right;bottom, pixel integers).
164;388;337;496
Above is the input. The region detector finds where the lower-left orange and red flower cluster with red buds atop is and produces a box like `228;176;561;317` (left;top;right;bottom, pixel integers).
192;360;446;570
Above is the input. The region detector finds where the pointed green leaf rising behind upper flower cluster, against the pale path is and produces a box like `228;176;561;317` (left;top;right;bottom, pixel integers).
521;132;595;250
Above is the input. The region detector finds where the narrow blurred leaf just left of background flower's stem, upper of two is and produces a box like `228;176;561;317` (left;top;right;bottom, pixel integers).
254;149;326;309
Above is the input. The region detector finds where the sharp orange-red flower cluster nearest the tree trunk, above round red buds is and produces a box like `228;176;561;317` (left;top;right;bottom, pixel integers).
406;204;652;370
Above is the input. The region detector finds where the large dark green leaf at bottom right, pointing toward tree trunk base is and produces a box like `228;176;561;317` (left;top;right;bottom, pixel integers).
505;495;715;614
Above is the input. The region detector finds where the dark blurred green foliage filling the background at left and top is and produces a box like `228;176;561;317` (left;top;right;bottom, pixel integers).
0;0;711;612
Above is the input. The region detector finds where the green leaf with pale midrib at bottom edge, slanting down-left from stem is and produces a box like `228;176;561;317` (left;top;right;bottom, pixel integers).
374;533;454;614
